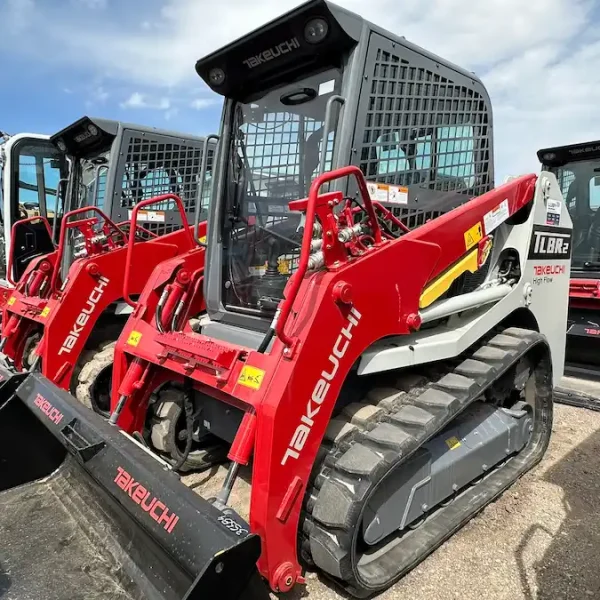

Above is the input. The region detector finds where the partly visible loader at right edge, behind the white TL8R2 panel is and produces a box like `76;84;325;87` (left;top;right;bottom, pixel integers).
538;141;600;410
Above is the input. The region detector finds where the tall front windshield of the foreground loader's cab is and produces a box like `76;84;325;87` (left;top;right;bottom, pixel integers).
223;69;341;313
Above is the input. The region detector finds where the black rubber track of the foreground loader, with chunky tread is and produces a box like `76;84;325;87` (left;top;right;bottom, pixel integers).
301;328;553;598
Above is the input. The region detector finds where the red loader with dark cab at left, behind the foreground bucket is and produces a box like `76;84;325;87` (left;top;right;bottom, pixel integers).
0;118;214;416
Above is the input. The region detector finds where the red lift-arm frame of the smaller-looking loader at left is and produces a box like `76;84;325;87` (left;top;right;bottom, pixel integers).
2;194;206;390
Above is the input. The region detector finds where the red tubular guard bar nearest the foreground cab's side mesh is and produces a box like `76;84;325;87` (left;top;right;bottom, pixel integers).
275;165;382;346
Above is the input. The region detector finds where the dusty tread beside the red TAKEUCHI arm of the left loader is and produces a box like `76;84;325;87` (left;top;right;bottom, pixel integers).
73;340;117;419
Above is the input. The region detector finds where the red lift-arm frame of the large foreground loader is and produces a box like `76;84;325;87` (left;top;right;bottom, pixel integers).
112;166;537;591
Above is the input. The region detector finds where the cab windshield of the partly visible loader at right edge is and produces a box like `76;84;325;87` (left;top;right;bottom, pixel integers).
550;159;600;271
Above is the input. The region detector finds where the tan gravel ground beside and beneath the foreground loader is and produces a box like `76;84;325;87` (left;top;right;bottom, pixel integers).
187;405;600;600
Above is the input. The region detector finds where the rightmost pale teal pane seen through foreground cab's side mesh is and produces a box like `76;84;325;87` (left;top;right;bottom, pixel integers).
436;125;475;188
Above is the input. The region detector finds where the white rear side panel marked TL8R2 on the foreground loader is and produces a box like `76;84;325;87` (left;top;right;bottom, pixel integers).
358;173;571;385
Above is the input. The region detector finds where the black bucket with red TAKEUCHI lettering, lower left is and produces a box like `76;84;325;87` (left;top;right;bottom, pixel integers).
0;373;268;600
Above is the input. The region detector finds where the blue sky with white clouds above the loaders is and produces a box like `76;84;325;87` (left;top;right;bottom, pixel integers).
0;0;600;183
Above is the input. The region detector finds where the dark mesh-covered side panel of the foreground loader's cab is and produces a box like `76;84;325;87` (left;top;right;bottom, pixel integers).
353;31;494;223
